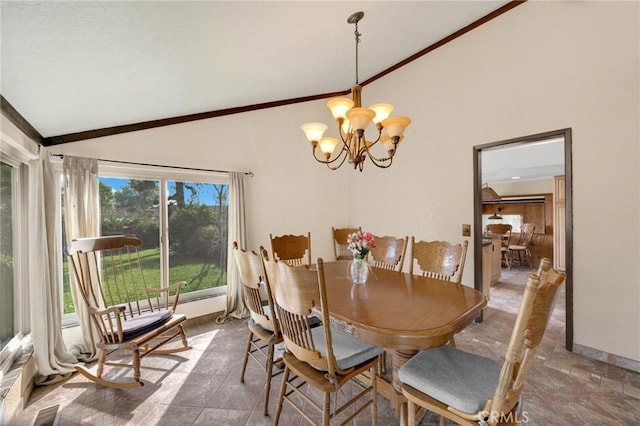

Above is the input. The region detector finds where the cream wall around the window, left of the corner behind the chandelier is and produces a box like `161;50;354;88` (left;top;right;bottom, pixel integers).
52;102;350;258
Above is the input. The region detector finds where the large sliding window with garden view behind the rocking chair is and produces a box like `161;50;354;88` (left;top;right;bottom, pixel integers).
64;168;228;314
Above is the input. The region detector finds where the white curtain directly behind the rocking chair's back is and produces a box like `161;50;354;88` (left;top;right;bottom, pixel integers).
62;155;100;361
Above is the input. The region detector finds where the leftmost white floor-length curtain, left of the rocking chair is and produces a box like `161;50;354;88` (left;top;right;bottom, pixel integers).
28;148;77;384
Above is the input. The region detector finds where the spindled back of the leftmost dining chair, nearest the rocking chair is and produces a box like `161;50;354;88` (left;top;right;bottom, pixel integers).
233;241;279;334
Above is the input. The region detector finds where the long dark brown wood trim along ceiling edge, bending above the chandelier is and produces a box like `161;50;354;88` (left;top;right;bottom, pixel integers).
39;0;526;146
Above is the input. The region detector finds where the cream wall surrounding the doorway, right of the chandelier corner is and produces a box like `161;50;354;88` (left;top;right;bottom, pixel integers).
352;2;640;360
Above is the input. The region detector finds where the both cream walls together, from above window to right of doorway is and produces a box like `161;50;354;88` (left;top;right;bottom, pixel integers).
57;2;640;360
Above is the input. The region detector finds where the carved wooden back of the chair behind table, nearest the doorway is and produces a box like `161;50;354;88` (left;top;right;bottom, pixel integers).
409;237;469;284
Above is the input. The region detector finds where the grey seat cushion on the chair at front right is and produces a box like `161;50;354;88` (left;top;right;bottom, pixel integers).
398;345;500;414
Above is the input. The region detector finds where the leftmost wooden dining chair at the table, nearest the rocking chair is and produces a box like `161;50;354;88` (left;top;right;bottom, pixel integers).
233;241;282;416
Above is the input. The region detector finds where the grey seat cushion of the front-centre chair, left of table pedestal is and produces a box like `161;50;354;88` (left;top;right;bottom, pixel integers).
311;325;382;370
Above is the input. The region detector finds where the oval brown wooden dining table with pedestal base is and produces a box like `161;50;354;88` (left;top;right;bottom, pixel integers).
324;261;487;424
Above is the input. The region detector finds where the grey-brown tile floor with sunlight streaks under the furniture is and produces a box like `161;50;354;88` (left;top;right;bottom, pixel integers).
9;268;640;426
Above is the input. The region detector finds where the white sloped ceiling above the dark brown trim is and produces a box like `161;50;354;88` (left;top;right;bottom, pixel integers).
0;0;509;138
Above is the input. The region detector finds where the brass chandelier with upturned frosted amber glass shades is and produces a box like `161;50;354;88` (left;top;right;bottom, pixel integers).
302;12;411;171
